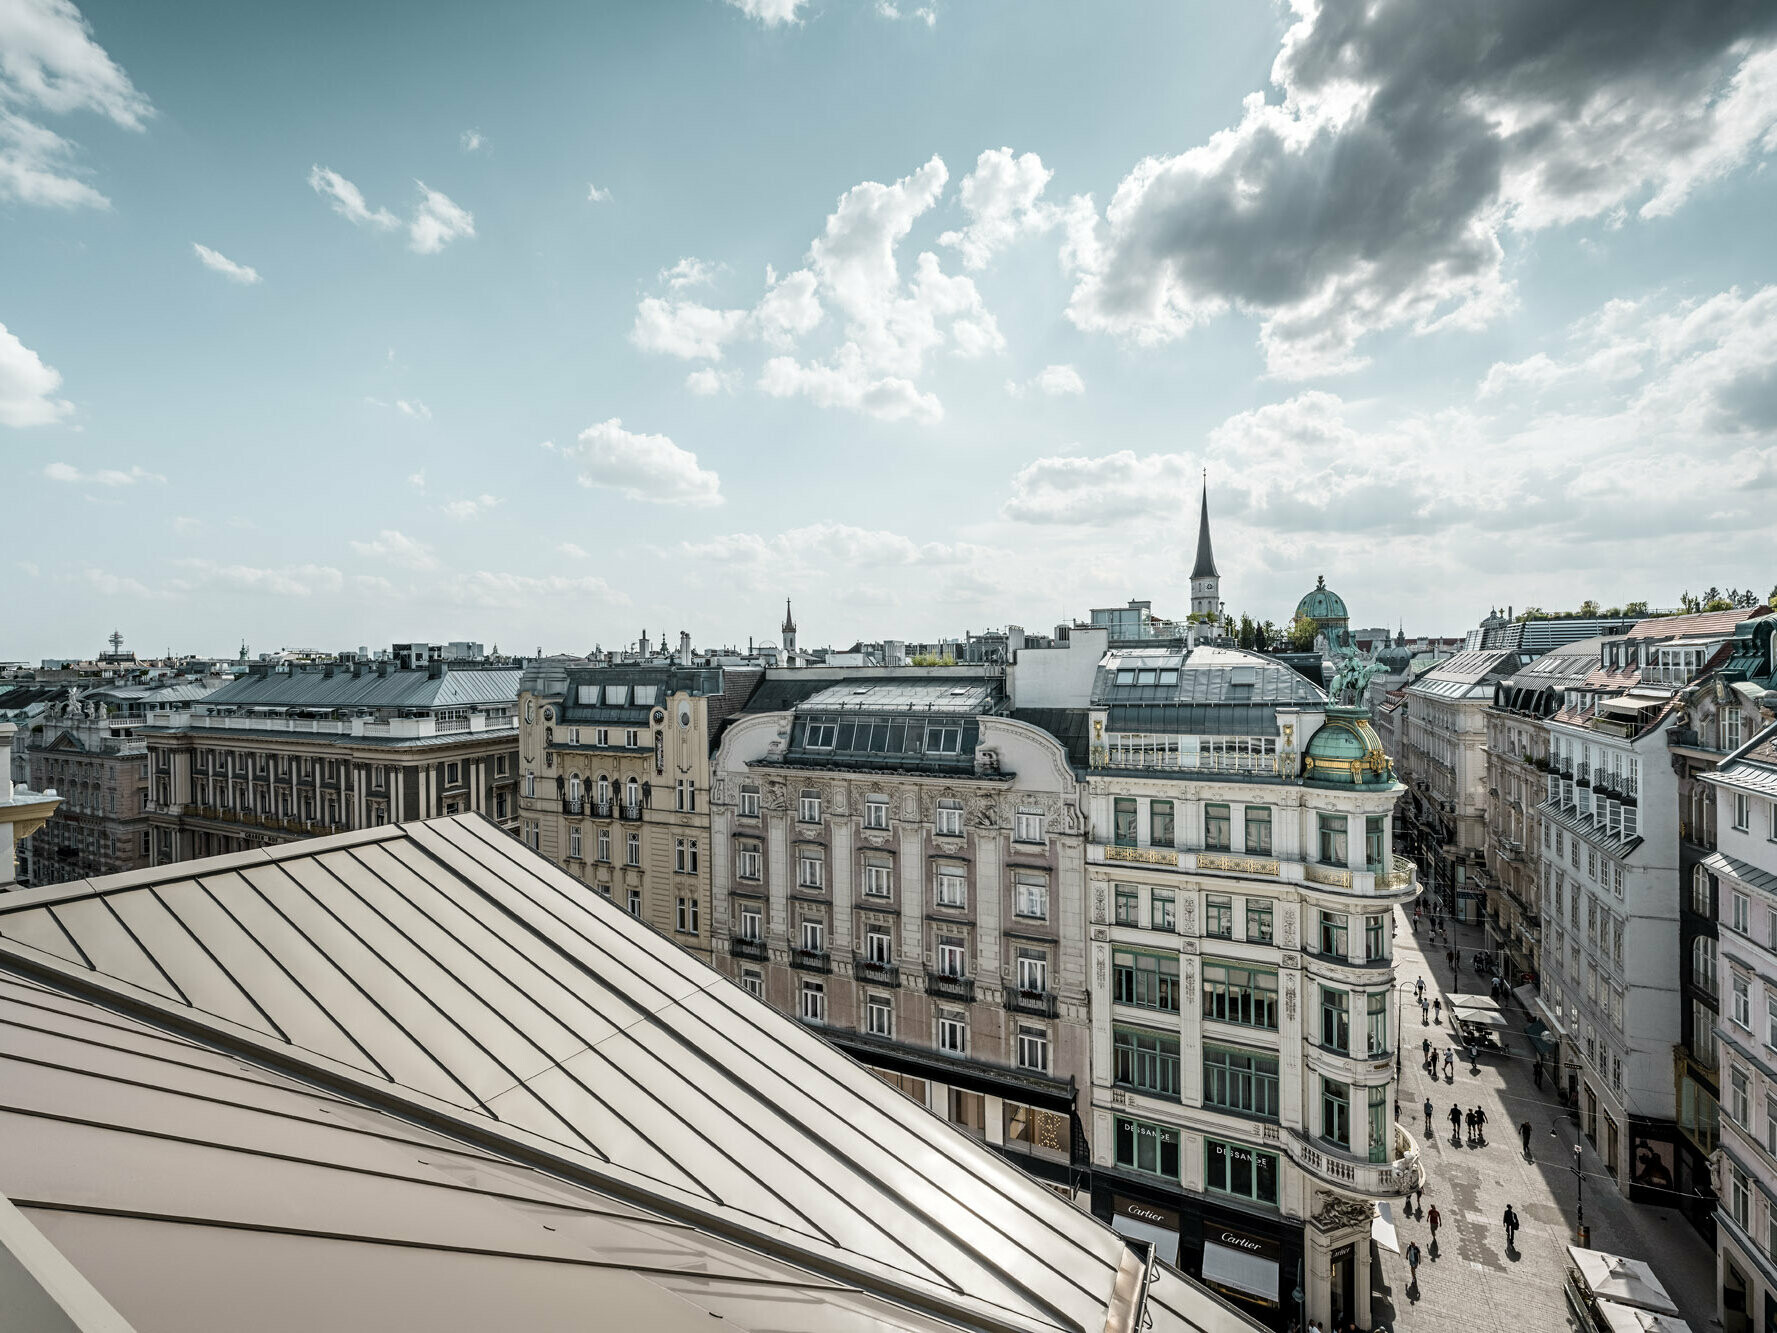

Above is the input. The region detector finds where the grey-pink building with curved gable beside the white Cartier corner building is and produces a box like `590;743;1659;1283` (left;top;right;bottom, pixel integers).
711;668;1091;1196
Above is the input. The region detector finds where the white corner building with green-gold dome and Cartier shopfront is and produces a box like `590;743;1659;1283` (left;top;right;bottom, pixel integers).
1086;645;1422;1329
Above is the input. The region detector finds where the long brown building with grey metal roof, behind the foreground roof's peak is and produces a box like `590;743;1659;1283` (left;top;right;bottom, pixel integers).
140;659;519;866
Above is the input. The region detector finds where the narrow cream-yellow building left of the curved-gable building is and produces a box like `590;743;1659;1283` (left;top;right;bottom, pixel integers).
517;664;760;962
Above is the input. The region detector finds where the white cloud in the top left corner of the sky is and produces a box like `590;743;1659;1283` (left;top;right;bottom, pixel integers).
0;0;155;208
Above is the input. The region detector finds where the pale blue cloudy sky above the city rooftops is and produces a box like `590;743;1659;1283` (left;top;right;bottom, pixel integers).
0;0;1777;659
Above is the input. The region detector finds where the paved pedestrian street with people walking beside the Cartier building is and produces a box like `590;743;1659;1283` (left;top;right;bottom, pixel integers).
1372;912;1718;1333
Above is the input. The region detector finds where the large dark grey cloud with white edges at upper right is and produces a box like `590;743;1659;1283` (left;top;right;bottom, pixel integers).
1063;0;1777;377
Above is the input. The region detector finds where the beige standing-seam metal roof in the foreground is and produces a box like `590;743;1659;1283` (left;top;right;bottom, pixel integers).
0;816;1255;1333
